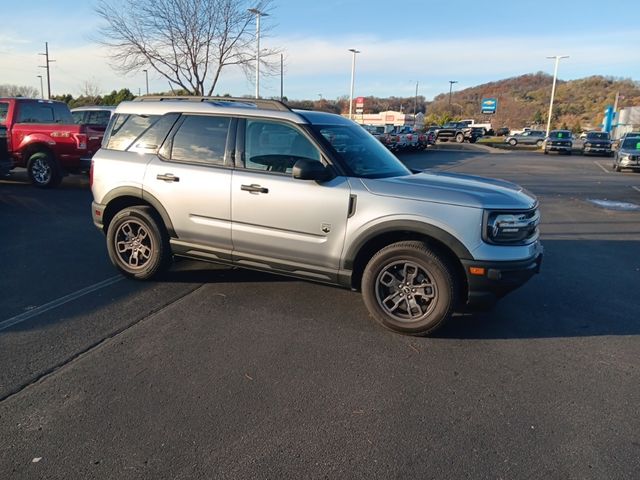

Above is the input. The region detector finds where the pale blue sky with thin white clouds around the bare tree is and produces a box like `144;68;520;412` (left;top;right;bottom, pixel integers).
0;0;640;100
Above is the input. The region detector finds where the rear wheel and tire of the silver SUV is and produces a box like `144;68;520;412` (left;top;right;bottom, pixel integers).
107;206;171;280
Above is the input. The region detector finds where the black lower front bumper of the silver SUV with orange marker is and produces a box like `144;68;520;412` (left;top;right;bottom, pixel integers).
462;251;543;307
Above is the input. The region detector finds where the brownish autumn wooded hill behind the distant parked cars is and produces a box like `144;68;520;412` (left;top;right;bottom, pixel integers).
427;72;640;131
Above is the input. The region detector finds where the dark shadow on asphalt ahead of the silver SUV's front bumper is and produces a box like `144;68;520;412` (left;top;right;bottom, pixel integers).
434;240;640;339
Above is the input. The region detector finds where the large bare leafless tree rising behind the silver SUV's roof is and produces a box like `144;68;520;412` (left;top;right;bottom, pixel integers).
96;0;276;95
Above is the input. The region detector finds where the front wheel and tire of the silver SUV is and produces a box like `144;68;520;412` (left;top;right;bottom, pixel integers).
362;241;457;335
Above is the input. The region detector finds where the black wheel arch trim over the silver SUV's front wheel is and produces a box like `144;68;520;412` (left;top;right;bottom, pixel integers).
343;220;473;299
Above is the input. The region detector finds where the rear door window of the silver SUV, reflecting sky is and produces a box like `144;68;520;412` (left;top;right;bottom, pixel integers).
171;115;231;165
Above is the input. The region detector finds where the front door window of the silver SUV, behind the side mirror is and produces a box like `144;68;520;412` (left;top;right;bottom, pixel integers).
245;120;320;173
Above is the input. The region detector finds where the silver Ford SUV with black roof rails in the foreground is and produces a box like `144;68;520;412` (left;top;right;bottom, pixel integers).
91;97;542;335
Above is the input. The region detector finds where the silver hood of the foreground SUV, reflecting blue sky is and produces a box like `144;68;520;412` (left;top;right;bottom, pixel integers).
361;172;537;209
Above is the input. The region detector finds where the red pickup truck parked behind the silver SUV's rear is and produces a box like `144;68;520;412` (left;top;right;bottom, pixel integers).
0;98;103;188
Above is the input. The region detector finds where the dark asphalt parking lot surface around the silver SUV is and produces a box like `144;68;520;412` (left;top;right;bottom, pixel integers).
0;146;640;479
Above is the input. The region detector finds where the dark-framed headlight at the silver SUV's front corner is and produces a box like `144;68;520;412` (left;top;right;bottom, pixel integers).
483;208;540;245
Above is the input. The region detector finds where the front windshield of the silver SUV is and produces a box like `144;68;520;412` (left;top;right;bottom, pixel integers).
313;125;411;178
